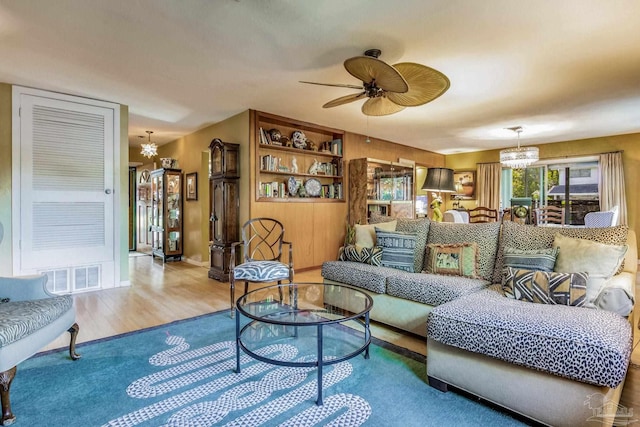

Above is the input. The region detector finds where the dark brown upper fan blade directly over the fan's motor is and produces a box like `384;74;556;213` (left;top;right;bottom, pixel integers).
344;56;409;93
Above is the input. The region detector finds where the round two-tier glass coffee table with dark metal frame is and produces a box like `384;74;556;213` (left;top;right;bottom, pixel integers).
236;283;373;405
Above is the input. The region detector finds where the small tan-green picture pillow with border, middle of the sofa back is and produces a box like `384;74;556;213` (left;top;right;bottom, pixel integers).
426;242;478;279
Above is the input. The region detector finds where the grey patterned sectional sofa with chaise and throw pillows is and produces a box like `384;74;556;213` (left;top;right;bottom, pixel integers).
322;218;637;426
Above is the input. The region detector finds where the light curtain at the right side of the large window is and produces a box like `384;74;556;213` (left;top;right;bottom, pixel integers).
598;151;627;225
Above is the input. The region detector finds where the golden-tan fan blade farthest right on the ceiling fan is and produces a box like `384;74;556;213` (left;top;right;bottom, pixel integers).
387;62;451;107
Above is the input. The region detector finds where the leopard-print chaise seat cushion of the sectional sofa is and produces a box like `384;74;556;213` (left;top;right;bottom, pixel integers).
427;289;633;387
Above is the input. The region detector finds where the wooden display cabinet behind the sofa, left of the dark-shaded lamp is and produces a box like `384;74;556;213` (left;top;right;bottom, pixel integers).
349;158;415;224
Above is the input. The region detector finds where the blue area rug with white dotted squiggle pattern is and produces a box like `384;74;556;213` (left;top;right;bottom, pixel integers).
12;311;522;427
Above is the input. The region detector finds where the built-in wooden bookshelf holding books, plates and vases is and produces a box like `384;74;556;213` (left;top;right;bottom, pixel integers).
254;112;345;202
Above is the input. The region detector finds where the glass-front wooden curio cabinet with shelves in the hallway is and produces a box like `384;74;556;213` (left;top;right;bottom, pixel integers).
150;169;183;261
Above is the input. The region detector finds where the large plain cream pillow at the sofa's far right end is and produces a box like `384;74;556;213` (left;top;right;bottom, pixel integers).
553;234;628;306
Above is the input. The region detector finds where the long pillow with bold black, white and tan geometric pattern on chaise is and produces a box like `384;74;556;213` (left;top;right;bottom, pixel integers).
503;267;589;307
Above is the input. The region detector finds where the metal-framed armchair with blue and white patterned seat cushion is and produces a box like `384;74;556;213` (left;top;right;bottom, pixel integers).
229;218;293;317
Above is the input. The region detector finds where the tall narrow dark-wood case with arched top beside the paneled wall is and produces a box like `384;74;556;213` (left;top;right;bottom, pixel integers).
209;138;240;281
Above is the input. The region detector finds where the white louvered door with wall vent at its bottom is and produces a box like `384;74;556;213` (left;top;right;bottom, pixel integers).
13;90;119;292
